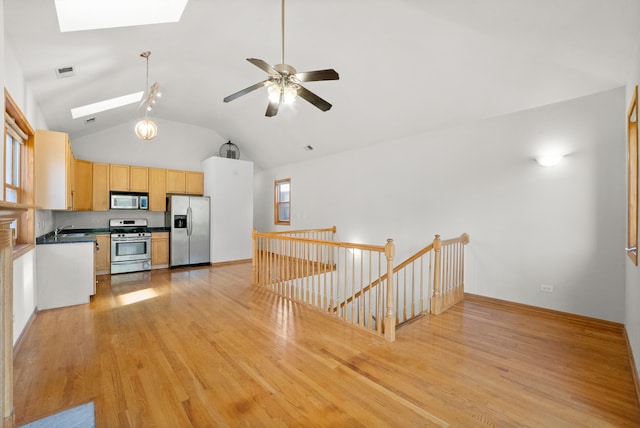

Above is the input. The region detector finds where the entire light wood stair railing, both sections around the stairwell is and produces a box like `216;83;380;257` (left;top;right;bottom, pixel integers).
252;226;469;341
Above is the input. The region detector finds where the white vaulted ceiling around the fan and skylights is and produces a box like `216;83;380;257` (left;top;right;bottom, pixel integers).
4;0;640;167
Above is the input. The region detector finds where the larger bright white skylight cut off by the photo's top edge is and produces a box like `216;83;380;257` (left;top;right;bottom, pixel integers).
55;0;188;33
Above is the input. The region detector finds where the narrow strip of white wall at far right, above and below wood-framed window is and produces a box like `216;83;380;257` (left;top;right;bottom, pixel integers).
625;43;640;382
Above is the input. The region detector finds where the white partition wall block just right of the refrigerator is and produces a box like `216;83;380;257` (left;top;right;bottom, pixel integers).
202;157;253;263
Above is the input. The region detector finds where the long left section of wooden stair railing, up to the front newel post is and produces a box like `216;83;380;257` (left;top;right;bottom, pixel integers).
252;227;395;341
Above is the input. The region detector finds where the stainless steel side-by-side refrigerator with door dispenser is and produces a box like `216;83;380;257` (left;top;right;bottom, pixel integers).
165;195;211;267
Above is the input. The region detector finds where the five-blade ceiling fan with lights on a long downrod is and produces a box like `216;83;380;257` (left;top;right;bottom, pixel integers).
223;0;340;117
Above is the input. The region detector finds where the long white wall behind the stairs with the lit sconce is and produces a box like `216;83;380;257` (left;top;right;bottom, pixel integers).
254;88;625;322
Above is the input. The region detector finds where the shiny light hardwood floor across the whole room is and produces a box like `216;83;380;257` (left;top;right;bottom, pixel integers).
14;264;640;427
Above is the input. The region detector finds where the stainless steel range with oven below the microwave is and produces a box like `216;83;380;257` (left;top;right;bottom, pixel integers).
109;218;151;274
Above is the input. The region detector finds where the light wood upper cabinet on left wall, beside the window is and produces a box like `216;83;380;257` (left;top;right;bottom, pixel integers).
35;130;74;210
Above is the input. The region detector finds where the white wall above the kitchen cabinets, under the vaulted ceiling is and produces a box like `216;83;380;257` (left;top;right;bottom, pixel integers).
72;118;227;171
